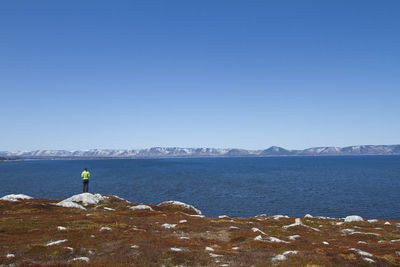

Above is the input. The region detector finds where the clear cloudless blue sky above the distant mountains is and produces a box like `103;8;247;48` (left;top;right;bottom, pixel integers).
0;0;400;150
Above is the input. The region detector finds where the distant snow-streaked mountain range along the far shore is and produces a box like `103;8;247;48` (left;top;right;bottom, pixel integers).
0;145;400;159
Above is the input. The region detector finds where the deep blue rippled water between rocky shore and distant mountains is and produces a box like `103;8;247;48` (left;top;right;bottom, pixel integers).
0;156;400;219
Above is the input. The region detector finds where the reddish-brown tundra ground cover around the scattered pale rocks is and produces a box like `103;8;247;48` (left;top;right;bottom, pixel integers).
0;197;400;267
